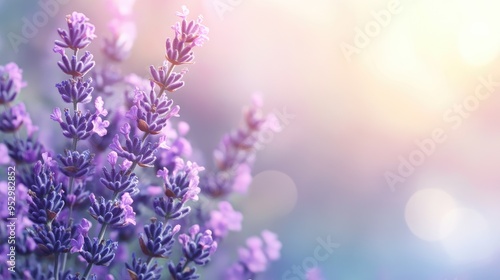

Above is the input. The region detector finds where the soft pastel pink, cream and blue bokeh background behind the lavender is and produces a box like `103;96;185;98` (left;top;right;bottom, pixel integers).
0;0;500;280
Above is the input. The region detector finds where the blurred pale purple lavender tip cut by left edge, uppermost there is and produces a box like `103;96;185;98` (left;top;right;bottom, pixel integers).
0;62;26;104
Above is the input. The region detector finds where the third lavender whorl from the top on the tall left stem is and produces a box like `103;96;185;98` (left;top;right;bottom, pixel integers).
56;77;94;104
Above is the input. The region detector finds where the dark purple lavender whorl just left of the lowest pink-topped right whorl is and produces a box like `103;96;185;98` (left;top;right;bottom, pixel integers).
139;220;180;258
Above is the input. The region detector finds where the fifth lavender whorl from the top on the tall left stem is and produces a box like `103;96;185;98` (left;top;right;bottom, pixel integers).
57;150;94;178
